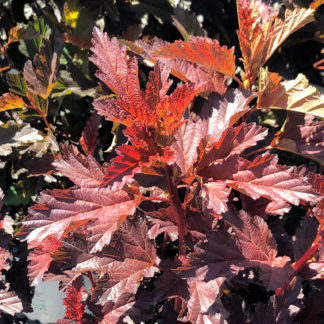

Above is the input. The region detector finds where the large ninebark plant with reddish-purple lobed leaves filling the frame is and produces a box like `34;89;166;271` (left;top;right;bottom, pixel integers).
0;0;324;324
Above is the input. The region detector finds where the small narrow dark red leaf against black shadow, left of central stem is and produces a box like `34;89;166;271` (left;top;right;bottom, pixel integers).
79;114;100;155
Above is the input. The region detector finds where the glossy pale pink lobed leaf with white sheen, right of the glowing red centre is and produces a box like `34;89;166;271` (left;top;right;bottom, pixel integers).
172;91;253;175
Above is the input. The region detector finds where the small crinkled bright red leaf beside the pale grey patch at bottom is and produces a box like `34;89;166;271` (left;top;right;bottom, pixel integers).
63;276;85;323
